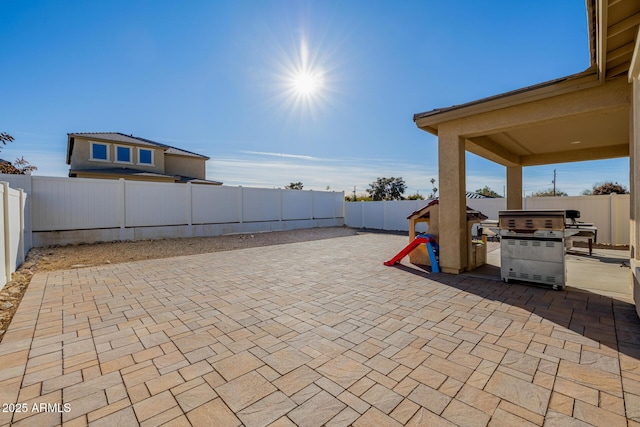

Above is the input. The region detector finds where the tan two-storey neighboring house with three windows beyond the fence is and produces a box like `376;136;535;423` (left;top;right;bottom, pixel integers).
67;132;222;185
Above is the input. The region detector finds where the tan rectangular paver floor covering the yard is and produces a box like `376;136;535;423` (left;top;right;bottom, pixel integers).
0;234;640;427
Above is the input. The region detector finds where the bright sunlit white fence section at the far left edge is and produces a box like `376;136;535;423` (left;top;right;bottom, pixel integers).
0;182;26;288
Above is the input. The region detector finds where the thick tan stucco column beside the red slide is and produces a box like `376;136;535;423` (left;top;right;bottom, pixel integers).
438;126;470;274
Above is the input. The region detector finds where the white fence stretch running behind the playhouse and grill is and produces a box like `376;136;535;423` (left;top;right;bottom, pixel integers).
345;194;630;245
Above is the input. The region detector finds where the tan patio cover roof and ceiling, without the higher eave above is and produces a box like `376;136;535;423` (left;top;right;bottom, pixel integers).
414;69;630;166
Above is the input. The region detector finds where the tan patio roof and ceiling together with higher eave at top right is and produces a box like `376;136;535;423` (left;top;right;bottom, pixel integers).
414;0;640;166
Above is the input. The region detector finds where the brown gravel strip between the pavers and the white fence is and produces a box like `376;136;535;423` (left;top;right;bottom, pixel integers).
0;227;358;342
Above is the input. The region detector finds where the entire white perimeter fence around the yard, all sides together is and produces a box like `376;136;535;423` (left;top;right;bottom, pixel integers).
0;170;630;274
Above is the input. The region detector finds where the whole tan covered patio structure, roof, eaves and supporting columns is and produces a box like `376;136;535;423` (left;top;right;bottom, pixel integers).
414;0;640;315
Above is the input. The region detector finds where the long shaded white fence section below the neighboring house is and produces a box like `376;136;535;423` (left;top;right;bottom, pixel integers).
0;175;344;249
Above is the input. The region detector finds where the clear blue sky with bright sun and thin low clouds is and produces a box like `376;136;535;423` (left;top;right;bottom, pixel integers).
0;0;629;195
